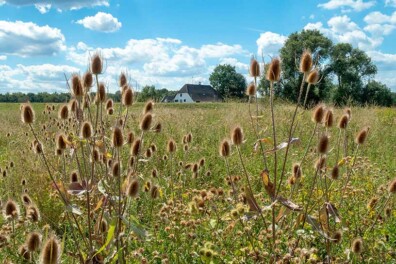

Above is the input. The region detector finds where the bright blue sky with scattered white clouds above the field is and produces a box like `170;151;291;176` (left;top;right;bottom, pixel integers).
0;0;396;93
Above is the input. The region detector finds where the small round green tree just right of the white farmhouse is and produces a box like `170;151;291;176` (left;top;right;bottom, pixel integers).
209;64;246;98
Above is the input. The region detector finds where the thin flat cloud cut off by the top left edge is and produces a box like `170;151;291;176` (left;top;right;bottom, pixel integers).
0;0;109;13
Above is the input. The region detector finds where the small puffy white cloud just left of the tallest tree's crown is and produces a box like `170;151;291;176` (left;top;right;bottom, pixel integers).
256;31;287;56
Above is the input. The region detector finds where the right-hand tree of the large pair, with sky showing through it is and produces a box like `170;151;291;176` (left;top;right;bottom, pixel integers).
328;43;377;104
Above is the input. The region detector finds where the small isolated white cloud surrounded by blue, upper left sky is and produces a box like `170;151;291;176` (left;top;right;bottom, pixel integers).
76;12;122;32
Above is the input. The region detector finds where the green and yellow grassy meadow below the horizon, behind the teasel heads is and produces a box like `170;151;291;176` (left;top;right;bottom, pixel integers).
0;101;396;263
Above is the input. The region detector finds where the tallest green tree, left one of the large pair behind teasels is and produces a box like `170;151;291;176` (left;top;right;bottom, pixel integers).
278;30;333;101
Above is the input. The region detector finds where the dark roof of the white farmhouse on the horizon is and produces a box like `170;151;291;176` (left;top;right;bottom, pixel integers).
179;84;221;102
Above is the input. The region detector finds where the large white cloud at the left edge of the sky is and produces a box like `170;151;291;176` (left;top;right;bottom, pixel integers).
0;20;65;57
